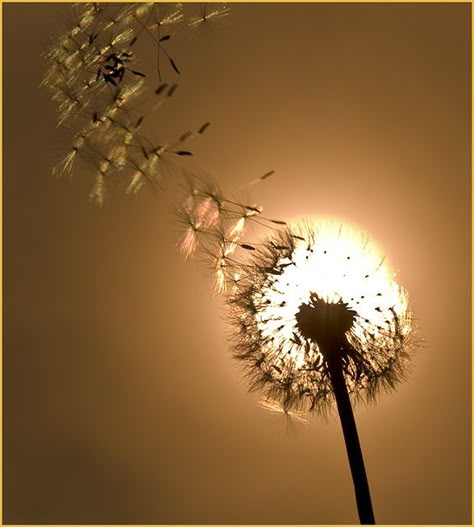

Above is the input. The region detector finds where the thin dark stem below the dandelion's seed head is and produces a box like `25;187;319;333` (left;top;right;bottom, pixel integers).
327;354;375;525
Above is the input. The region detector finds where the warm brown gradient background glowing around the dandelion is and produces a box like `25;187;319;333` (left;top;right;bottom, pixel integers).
3;4;471;524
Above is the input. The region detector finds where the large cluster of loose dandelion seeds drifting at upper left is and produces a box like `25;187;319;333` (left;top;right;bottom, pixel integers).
42;2;229;205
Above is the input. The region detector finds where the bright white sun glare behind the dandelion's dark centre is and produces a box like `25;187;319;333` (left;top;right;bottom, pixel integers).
257;222;406;352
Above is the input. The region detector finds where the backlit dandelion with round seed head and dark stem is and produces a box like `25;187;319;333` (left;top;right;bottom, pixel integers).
228;219;413;523
